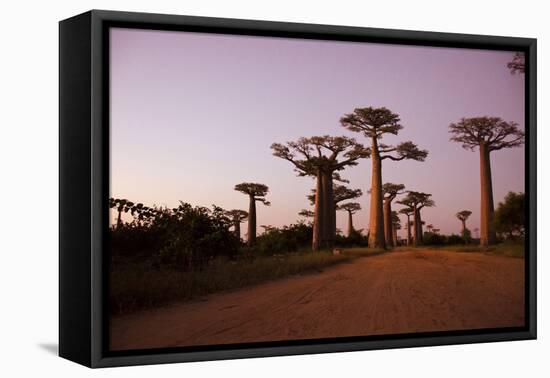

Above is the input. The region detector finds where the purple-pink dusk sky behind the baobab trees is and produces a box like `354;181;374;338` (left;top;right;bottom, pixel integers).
111;28;524;235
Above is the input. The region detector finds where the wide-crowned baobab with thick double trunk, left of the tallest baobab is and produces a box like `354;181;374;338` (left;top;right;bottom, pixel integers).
271;135;370;251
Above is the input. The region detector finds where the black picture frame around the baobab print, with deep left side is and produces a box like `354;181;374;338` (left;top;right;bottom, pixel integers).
59;10;537;367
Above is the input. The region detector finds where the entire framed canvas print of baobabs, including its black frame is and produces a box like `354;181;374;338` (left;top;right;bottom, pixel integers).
59;10;536;367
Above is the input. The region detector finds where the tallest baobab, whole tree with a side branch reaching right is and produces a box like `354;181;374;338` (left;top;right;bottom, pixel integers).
340;107;428;248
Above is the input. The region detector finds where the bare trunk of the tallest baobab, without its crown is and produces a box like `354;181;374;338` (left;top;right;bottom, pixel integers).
369;137;386;249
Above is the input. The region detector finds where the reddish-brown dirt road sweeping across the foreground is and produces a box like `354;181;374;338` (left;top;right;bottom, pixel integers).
111;250;524;350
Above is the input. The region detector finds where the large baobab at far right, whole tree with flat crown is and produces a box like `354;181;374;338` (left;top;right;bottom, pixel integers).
449;117;525;246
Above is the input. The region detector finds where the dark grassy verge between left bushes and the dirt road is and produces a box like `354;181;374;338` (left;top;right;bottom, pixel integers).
110;248;383;314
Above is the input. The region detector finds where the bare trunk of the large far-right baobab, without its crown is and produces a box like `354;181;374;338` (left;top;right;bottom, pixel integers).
479;143;496;246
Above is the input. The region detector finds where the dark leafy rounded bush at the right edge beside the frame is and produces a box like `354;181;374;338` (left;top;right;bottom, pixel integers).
494;192;525;239
